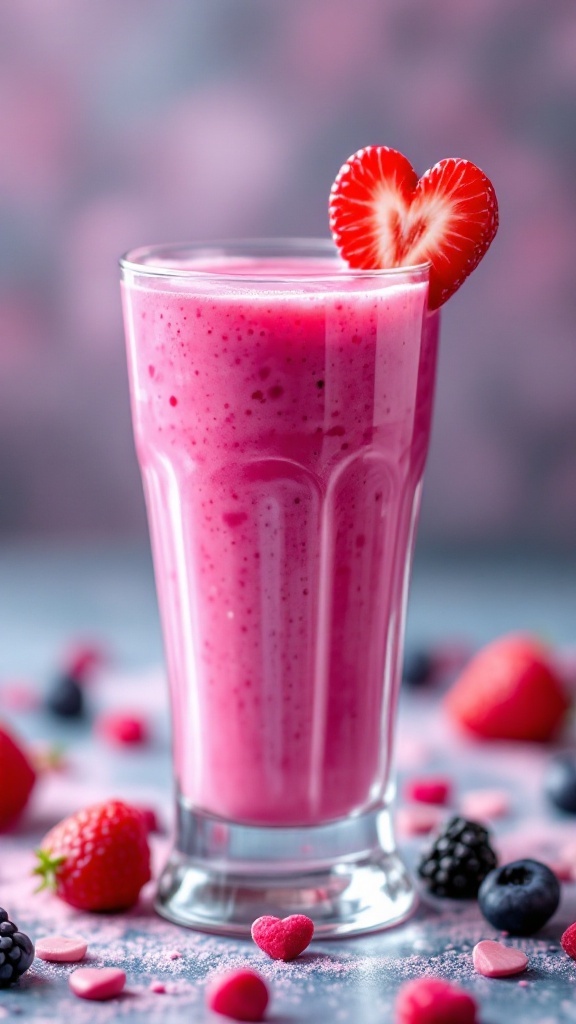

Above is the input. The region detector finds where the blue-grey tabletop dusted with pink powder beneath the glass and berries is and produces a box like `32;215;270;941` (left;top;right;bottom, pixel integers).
0;545;576;1024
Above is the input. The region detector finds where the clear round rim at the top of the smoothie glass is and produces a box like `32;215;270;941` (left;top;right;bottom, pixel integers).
119;237;430;283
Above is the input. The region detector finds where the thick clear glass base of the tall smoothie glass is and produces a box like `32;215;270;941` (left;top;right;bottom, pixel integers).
156;799;416;938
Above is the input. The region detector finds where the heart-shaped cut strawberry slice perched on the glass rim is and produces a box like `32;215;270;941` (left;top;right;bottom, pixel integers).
330;145;498;309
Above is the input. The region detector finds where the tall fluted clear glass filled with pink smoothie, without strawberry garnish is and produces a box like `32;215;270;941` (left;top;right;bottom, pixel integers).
122;241;438;935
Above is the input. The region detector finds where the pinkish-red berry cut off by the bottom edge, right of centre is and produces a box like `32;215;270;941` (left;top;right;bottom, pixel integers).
395;978;478;1024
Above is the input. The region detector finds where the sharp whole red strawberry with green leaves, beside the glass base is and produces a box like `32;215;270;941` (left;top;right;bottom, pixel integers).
35;800;151;910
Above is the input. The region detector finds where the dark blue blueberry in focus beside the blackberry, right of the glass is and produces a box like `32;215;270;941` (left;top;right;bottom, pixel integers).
478;860;560;935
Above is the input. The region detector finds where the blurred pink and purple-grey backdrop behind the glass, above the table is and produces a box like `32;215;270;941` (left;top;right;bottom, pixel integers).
0;0;576;548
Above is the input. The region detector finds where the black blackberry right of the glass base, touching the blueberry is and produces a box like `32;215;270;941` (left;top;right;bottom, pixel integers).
418;817;497;899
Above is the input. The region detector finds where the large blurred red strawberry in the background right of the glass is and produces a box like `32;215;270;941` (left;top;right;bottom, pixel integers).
446;634;570;740
